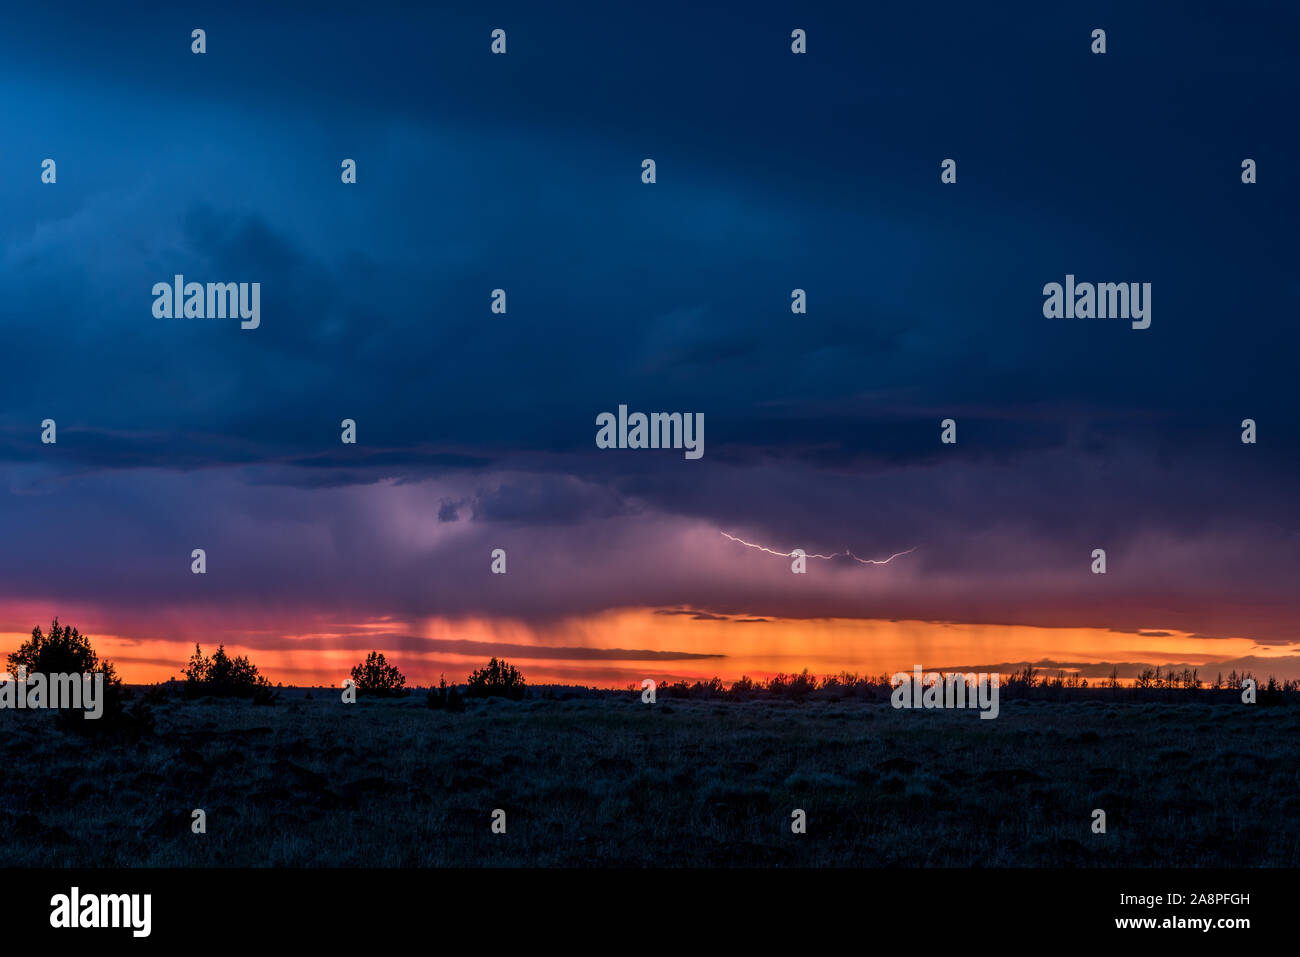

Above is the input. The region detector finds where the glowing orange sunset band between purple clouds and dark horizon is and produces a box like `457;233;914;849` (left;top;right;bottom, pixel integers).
0;609;1300;688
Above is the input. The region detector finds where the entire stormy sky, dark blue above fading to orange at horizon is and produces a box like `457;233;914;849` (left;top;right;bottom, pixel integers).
0;3;1300;687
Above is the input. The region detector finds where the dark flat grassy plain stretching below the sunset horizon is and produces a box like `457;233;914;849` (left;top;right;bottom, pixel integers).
0;693;1300;867
